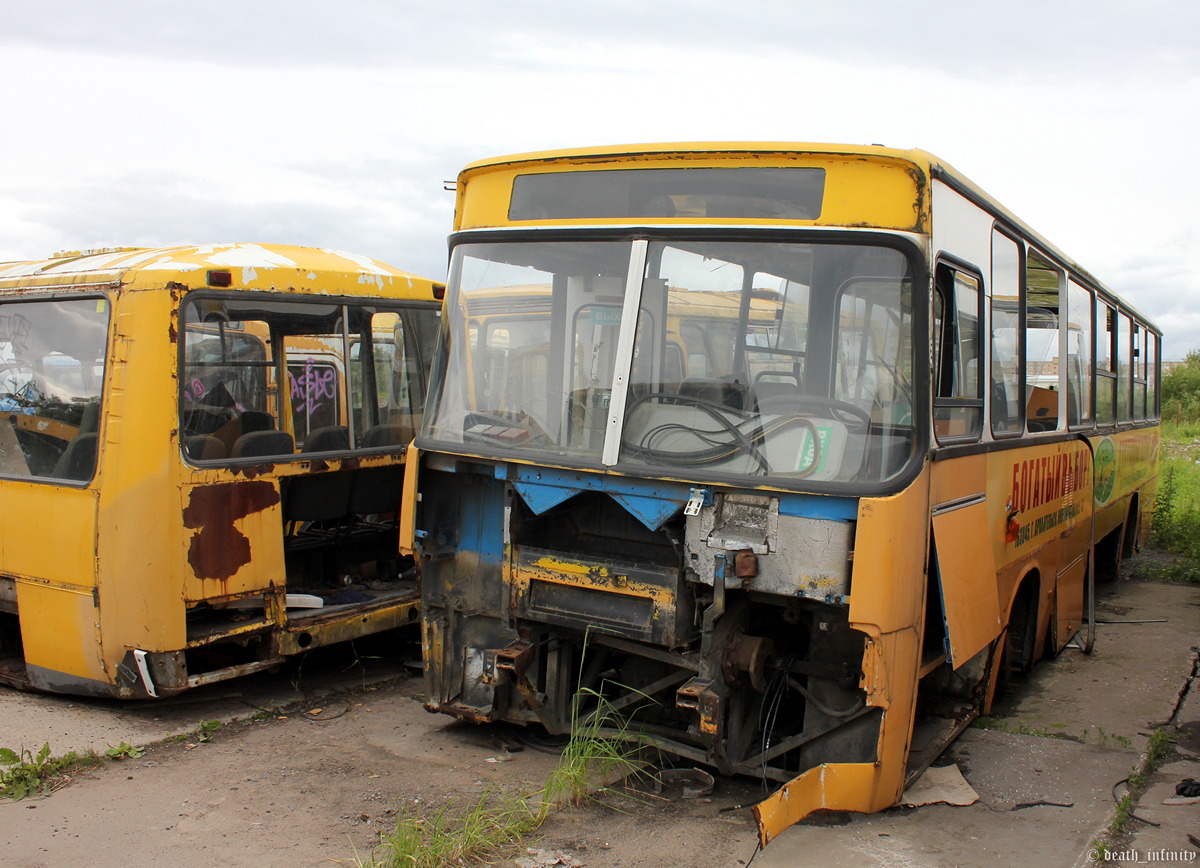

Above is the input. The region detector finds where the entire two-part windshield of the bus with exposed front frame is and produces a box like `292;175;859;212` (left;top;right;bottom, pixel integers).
426;239;914;486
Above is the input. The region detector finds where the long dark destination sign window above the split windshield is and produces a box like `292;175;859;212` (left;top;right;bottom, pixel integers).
509;167;824;220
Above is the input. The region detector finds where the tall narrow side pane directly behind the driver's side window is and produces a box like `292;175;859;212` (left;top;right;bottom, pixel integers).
990;232;1025;435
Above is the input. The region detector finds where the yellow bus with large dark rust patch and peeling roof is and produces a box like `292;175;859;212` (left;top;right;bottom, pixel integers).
0;244;443;699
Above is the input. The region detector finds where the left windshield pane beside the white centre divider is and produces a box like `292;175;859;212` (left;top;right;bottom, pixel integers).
426;241;630;459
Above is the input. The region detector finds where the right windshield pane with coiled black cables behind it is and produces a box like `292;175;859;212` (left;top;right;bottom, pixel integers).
620;241;913;483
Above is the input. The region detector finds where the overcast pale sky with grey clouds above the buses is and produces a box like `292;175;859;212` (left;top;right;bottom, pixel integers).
0;0;1200;359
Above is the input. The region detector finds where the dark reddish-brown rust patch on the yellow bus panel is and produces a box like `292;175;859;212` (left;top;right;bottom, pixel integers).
184;481;280;581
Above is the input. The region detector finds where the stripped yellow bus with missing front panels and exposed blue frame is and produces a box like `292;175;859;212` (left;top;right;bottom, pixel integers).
414;143;1160;843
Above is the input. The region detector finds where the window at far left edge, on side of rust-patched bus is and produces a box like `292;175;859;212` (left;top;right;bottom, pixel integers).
0;298;109;481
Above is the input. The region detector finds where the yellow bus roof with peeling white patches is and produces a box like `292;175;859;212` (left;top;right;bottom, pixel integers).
0;244;436;301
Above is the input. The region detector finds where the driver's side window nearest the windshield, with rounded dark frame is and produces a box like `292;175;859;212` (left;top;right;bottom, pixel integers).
934;263;983;443
